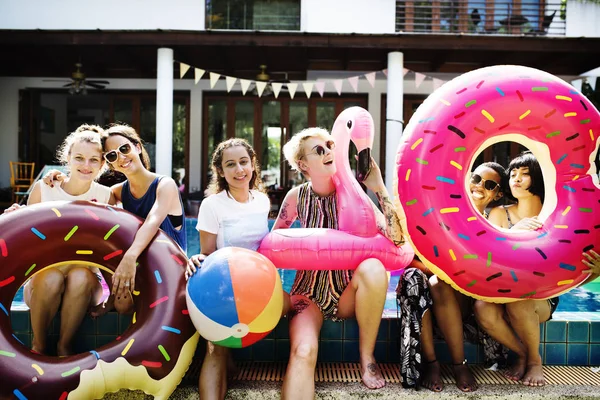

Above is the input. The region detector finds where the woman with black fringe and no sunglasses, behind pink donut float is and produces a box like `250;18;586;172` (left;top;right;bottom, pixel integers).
475;152;558;386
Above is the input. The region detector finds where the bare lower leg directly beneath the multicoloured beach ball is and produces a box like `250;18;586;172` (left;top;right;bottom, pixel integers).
198;342;230;400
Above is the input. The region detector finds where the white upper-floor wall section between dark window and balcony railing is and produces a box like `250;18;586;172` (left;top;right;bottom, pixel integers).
300;0;396;33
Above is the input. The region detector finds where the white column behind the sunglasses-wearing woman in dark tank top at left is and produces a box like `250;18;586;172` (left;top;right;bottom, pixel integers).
156;48;173;176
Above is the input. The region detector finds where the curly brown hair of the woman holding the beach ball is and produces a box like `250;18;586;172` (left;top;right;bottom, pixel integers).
206;138;264;194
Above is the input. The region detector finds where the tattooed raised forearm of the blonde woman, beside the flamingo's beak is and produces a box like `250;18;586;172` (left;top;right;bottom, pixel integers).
363;157;406;246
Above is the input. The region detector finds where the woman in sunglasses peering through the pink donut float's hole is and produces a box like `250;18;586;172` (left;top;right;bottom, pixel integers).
421;162;508;392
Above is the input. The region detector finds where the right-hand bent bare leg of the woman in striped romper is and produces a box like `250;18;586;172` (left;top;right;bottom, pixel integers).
337;259;388;389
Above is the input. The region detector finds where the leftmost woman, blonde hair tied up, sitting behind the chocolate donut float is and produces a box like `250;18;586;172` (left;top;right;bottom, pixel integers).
5;124;115;356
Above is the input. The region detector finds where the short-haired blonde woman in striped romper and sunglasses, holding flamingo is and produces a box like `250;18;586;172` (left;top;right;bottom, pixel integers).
273;128;412;399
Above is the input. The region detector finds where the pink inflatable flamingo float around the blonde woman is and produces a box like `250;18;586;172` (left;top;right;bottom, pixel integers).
258;107;414;271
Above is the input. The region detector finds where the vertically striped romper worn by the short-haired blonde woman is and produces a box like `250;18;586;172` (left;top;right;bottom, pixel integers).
292;182;352;321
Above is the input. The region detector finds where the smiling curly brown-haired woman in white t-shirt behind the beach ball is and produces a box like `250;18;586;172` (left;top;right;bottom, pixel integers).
186;138;284;399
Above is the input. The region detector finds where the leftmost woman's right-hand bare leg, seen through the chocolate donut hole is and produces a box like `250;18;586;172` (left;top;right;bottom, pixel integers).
56;267;102;356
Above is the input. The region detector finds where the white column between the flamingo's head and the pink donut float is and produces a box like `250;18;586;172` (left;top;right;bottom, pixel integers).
385;51;404;192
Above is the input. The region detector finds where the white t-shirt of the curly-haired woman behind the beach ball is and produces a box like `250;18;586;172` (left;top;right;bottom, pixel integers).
196;190;271;250
